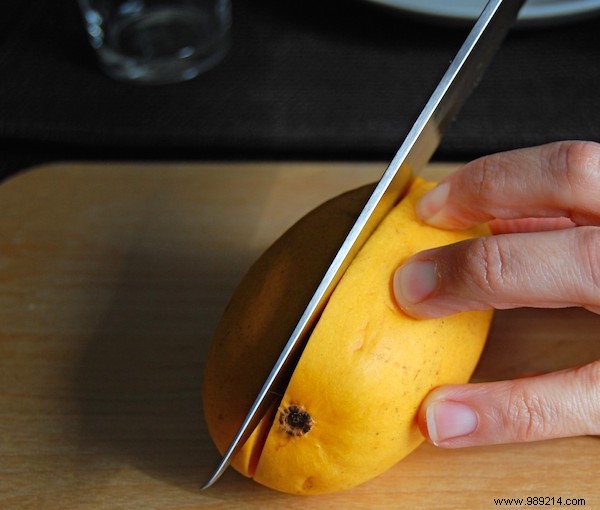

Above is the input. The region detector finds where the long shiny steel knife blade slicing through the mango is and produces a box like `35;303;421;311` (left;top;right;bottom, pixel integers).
201;0;525;490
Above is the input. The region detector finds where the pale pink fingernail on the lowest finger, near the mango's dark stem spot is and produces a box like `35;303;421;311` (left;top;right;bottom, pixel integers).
425;401;479;445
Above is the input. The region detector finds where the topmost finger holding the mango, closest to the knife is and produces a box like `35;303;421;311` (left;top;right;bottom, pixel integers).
417;141;600;229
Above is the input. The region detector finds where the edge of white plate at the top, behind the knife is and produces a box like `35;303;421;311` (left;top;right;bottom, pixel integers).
368;0;600;25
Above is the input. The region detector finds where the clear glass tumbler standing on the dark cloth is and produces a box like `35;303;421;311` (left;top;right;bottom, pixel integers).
79;0;231;84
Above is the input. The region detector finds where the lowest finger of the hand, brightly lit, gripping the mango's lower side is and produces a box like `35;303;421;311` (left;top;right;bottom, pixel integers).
418;360;600;448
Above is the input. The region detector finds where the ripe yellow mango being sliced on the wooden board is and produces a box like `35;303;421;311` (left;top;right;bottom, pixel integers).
203;180;492;495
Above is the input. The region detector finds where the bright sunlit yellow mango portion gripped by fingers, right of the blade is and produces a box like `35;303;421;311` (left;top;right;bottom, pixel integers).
254;183;492;494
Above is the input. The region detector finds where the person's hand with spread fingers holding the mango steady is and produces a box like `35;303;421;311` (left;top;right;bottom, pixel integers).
394;142;600;447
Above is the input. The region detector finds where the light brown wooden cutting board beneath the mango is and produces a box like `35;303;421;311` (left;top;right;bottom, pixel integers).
0;163;600;510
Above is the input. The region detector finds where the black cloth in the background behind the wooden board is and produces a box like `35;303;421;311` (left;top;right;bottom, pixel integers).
0;0;600;181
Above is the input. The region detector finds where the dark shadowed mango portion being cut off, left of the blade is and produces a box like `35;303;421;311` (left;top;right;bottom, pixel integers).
202;185;373;476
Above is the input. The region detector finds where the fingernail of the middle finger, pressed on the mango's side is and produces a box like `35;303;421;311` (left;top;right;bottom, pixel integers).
393;260;438;305
